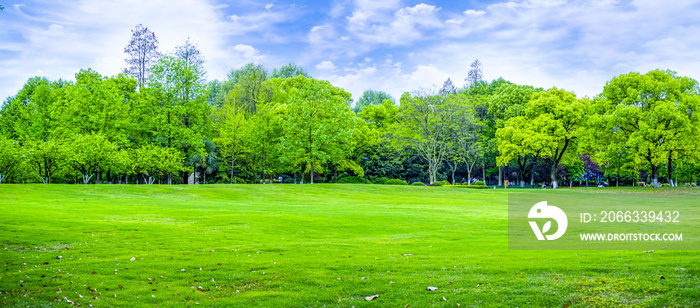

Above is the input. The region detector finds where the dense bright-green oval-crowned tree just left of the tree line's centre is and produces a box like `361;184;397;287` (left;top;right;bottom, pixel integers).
280;76;354;184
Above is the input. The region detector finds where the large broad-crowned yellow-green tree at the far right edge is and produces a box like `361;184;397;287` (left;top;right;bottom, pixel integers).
590;70;700;188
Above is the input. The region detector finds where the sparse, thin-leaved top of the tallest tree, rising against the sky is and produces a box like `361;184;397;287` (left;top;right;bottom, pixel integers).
124;24;160;88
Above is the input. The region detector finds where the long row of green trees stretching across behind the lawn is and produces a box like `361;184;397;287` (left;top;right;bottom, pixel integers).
0;25;700;187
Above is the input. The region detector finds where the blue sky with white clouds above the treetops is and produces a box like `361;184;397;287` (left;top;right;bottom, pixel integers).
0;0;700;103
